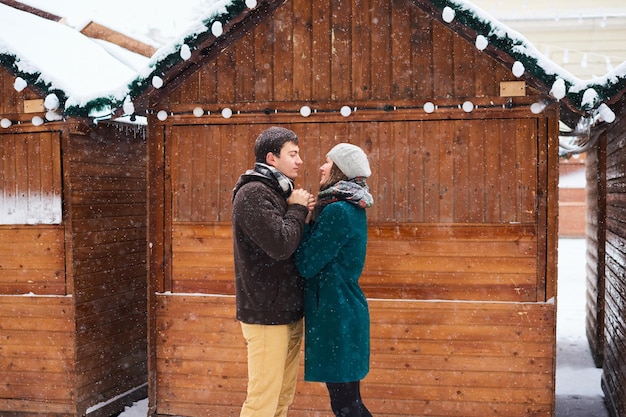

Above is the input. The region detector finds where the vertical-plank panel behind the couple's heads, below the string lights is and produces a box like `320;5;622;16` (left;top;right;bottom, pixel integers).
167;115;546;224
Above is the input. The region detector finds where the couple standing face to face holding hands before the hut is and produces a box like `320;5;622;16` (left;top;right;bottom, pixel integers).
233;127;373;417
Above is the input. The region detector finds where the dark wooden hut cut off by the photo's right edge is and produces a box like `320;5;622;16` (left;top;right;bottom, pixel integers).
586;79;626;417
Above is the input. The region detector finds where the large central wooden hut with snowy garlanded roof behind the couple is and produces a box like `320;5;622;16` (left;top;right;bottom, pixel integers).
113;0;604;417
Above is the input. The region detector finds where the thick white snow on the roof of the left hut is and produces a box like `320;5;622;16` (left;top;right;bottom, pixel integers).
0;3;136;116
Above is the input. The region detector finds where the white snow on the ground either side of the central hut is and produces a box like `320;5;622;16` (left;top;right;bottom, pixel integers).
119;239;608;417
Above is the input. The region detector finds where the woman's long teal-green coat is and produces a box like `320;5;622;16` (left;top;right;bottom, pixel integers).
296;201;370;382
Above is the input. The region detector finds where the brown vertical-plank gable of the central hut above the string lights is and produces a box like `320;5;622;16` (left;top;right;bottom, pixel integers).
160;0;532;111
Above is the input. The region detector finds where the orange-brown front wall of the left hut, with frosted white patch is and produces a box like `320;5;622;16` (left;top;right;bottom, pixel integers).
0;117;76;416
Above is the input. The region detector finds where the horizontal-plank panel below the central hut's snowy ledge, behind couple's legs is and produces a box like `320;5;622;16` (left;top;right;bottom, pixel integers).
156;295;555;417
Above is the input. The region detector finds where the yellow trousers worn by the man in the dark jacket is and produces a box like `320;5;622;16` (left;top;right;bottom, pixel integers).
240;320;303;417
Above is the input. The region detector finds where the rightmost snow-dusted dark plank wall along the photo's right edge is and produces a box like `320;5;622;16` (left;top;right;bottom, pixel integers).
602;93;626;416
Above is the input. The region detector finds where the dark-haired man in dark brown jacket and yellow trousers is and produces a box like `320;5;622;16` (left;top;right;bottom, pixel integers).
233;127;315;417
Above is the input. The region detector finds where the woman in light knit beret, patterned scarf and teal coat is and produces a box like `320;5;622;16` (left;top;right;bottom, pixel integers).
296;143;373;417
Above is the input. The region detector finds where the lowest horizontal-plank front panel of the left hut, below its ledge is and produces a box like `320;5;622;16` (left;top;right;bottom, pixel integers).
0;295;76;417
